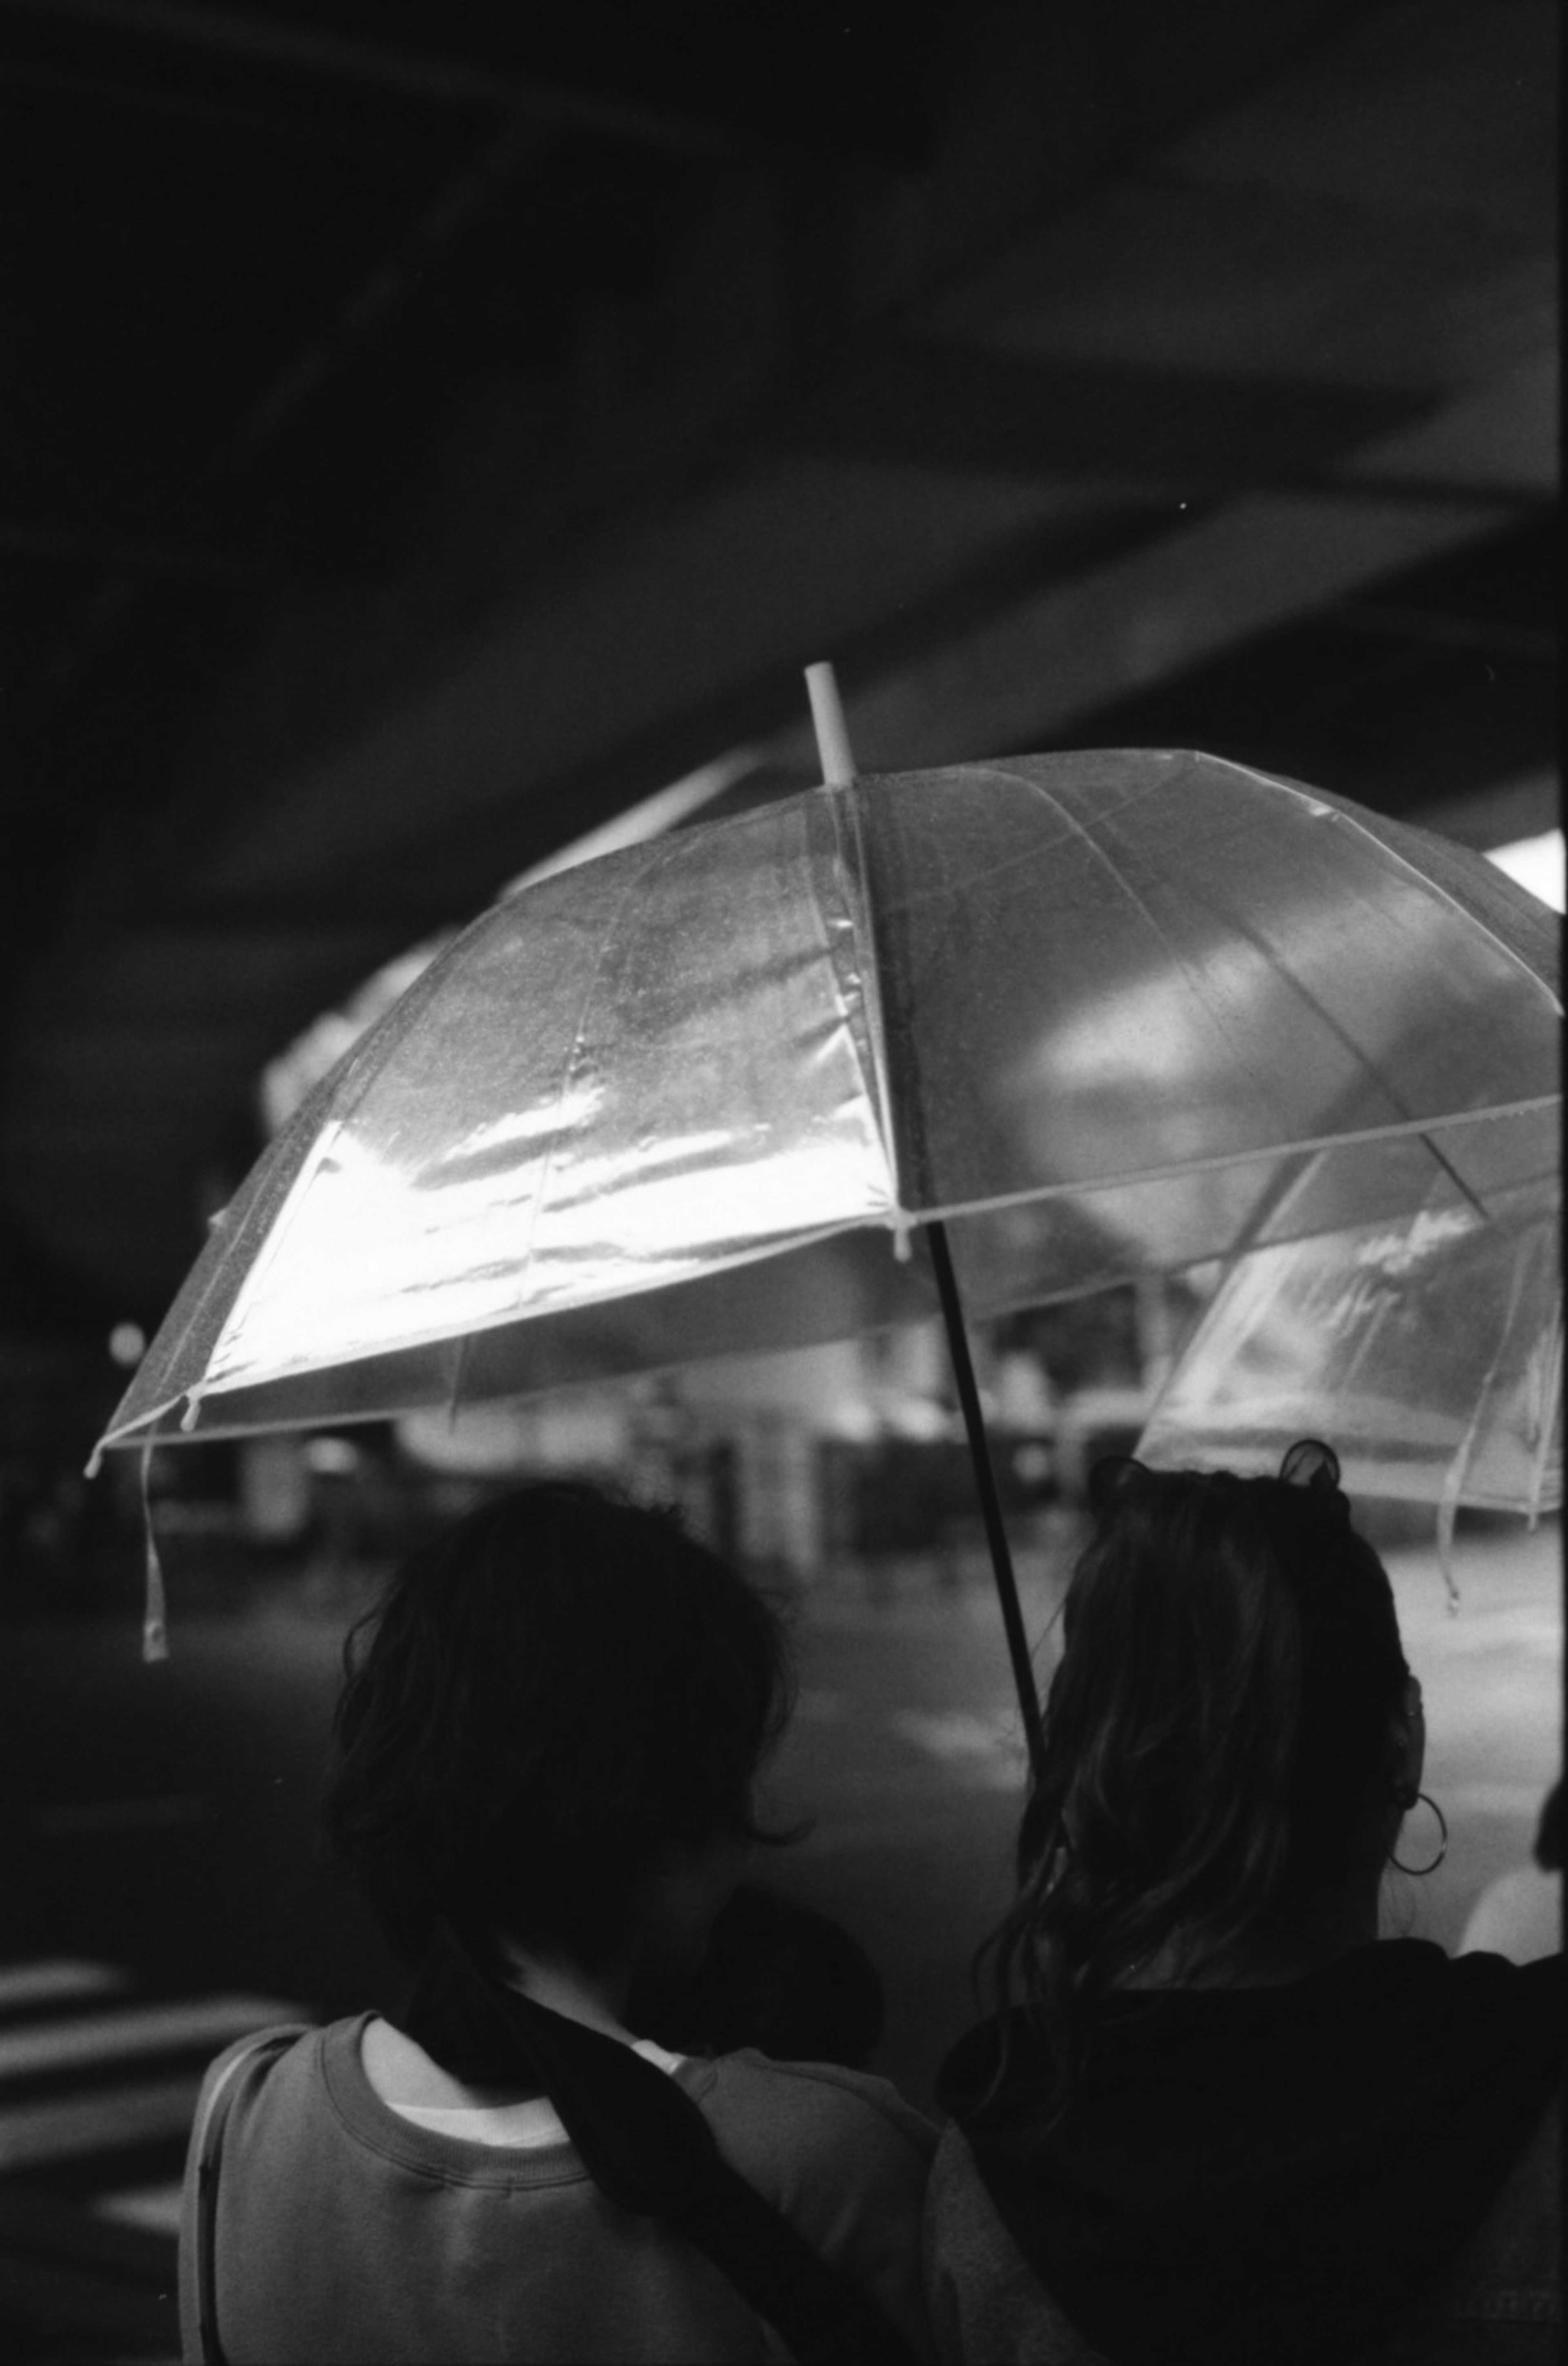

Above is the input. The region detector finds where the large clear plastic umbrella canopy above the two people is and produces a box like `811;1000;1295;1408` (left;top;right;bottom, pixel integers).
104;750;1561;1446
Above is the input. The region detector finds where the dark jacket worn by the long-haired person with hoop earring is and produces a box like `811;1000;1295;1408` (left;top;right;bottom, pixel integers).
927;1940;1566;2366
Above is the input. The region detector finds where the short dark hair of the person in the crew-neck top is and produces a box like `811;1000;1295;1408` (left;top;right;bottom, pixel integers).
324;1479;792;1964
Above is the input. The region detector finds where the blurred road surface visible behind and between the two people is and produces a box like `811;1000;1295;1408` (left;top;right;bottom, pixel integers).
0;1524;1561;2354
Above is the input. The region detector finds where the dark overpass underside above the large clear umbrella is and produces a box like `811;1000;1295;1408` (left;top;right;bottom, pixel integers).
0;0;1556;1330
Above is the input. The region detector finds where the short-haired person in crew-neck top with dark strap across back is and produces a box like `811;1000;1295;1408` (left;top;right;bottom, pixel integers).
180;1481;934;2366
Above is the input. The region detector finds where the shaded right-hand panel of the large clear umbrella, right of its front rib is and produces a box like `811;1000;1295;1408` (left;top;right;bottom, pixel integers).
861;752;1561;1223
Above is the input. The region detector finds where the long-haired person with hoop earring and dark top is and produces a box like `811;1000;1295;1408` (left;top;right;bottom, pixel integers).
927;1441;1563;2366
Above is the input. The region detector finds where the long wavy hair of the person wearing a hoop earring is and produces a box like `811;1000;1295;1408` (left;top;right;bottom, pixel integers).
982;1441;1410;2113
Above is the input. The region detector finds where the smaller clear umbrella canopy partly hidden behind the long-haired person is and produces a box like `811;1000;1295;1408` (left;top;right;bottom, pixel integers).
1138;1190;1563;1519
